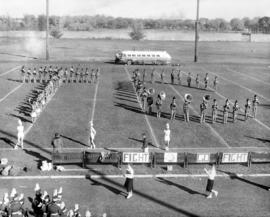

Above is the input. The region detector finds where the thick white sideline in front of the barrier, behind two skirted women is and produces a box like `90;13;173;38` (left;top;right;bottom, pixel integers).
0;173;270;180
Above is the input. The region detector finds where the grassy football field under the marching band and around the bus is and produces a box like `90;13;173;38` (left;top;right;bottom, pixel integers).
0;39;270;216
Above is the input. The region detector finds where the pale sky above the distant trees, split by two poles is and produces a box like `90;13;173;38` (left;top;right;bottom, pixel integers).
0;0;270;20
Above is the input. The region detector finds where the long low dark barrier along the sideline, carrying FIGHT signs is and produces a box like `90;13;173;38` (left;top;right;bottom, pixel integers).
52;151;270;168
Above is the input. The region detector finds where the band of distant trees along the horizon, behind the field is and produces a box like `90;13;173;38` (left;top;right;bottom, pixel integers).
0;15;270;34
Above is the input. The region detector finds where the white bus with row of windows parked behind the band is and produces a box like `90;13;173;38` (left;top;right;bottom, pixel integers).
115;50;172;65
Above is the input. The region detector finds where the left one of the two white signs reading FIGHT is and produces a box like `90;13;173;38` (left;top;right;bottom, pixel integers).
122;152;150;163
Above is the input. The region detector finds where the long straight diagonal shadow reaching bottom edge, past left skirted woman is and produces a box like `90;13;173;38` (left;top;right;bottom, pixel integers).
86;171;200;217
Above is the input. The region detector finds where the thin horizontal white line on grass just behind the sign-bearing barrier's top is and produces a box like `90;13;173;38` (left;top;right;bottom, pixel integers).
0;146;270;152
